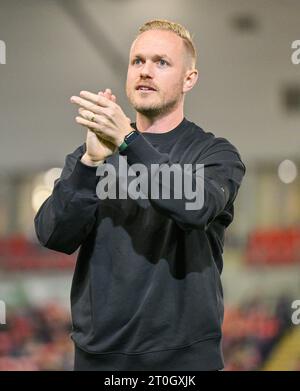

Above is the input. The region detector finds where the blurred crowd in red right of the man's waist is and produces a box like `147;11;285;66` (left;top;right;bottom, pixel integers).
223;297;291;371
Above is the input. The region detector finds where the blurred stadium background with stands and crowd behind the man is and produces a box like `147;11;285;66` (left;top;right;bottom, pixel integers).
0;0;300;371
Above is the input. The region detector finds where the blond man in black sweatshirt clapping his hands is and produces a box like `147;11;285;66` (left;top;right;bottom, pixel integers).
35;20;245;370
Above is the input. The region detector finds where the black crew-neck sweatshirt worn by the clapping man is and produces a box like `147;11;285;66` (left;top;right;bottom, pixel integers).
35;118;245;370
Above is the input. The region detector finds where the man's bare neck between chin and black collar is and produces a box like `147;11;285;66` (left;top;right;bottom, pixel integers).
136;105;184;133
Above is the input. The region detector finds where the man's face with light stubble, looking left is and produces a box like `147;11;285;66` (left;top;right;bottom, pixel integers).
126;30;186;117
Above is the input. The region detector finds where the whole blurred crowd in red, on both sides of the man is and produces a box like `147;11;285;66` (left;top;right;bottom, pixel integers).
0;298;290;371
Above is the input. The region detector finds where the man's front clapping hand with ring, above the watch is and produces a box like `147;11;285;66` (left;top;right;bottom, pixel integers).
71;91;133;147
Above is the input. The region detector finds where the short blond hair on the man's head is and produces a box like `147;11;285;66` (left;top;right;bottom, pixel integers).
137;19;197;68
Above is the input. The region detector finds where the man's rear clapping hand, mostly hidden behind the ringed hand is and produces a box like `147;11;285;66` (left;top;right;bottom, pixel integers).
79;88;117;166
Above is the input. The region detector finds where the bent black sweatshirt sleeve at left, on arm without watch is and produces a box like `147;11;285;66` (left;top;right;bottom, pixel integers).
34;144;99;254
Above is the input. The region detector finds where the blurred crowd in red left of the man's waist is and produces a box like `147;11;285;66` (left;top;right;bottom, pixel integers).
0;303;74;371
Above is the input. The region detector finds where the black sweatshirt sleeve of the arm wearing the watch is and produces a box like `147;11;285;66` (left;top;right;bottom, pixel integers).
121;135;246;230
